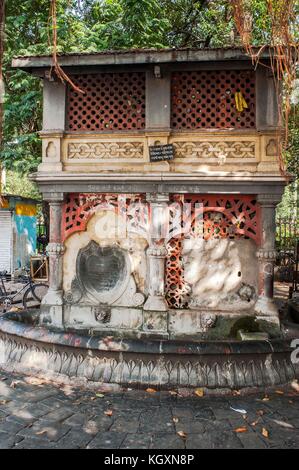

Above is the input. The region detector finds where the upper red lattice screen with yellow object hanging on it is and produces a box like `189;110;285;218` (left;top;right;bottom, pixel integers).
171;70;255;129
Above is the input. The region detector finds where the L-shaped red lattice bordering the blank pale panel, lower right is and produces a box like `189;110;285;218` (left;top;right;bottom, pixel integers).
165;194;261;308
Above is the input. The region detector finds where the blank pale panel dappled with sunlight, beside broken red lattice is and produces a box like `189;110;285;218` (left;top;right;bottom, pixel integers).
182;239;257;309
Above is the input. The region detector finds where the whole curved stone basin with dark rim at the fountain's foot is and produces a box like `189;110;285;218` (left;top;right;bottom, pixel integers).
0;316;299;389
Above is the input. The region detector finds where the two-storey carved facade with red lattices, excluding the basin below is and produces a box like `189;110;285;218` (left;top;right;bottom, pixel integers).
11;50;285;339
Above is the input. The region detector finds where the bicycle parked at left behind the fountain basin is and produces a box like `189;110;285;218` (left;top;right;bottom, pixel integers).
0;271;49;313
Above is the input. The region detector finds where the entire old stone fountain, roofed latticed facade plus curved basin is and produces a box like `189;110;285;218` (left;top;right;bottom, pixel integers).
0;48;298;388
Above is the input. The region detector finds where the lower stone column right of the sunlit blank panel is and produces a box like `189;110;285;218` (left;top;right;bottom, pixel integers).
255;194;280;324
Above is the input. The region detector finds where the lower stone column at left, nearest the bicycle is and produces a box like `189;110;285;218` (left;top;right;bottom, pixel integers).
40;193;64;327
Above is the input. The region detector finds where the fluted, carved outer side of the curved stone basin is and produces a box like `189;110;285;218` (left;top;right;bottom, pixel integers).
0;332;299;389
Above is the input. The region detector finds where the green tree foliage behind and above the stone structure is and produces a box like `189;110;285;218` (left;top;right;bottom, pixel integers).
0;0;299;217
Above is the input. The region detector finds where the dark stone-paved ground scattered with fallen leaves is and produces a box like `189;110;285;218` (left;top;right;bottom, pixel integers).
0;371;299;449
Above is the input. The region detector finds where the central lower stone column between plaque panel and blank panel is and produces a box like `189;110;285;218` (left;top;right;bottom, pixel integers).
144;193;169;318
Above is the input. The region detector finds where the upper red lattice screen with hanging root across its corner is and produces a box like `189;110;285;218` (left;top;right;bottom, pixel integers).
67;72;145;131
